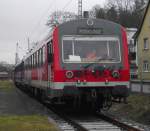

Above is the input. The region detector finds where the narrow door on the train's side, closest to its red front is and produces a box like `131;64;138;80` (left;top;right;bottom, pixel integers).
47;41;53;89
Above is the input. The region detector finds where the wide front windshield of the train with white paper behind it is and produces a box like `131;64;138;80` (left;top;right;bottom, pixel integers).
62;36;121;63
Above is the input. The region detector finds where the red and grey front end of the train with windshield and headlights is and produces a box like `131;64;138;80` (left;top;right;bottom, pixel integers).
52;19;129;108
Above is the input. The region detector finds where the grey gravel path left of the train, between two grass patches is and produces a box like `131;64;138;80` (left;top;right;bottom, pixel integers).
0;88;47;115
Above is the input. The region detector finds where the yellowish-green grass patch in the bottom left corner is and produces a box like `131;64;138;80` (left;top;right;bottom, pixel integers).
0;115;57;131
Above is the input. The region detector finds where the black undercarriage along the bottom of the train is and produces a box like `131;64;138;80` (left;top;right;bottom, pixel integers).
16;83;128;111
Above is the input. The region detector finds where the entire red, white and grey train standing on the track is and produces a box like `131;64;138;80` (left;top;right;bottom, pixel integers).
15;19;130;108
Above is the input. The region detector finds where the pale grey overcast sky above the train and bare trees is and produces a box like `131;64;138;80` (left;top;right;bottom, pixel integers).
0;0;106;64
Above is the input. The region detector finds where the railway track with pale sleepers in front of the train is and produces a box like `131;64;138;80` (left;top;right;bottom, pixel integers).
46;102;144;131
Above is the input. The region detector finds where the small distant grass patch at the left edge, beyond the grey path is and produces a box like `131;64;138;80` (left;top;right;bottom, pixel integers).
0;80;14;91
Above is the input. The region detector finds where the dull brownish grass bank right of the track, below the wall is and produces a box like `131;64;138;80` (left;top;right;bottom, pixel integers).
111;94;150;125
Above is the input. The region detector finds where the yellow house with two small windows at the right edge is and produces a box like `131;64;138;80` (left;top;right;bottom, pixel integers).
135;1;150;81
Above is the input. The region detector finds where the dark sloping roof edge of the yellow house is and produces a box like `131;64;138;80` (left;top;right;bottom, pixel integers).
133;0;150;39
